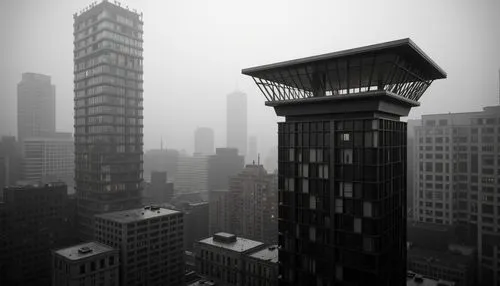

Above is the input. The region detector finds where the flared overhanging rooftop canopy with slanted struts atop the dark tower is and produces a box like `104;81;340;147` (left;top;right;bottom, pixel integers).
242;39;446;104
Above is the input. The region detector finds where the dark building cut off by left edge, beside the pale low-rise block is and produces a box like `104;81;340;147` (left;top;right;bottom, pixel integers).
0;136;22;191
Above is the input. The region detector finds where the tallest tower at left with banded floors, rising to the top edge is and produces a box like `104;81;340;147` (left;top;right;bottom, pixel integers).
73;1;143;239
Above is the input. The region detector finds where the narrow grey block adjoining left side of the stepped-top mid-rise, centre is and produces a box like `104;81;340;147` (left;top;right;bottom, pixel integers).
208;189;229;235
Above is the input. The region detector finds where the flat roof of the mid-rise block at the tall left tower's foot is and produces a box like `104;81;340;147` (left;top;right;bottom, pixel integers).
95;207;181;223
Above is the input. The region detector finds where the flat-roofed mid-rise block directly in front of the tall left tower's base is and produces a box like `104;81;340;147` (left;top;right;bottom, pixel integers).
95;206;184;286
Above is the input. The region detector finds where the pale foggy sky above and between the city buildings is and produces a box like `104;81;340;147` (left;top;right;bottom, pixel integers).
0;0;500;155
